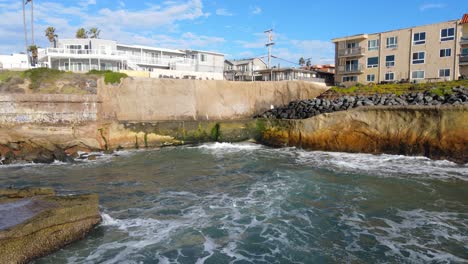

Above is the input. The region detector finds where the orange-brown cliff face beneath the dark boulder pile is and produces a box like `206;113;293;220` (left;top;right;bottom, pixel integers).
258;106;468;163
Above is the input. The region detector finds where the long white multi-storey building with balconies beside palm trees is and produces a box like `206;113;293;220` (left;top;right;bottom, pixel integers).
39;39;224;80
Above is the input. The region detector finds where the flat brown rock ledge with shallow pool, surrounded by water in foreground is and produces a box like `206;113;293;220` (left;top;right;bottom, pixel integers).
0;188;101;263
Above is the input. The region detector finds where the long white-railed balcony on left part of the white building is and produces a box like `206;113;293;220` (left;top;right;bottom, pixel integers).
39;48;126;60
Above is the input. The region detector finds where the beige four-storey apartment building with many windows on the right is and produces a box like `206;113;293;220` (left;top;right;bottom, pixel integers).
332;14;468;85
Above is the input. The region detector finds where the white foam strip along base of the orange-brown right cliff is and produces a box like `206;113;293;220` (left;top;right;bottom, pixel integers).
297;150;468;181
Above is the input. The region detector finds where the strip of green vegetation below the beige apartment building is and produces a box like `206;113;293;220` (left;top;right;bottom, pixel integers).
330;80;468;95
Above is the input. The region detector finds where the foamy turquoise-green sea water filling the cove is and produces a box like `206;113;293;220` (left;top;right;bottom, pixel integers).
0;143;468;263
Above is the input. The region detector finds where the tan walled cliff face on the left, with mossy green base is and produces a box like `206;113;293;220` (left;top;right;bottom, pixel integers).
0;78;327;161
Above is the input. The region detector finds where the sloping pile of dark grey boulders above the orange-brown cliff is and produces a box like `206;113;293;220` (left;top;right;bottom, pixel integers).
256;86;468;119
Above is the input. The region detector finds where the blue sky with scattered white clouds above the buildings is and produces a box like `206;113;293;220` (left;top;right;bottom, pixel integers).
0;0;468;66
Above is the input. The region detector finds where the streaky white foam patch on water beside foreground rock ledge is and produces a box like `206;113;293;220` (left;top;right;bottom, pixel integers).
68;171;307;263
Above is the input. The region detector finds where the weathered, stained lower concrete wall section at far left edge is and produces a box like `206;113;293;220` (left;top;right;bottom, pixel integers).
0;94;100;125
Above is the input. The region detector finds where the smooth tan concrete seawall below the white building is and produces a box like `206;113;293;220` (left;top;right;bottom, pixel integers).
98;78;327;121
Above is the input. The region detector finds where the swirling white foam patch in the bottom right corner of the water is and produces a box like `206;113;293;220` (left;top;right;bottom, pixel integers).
340;209;468;263
